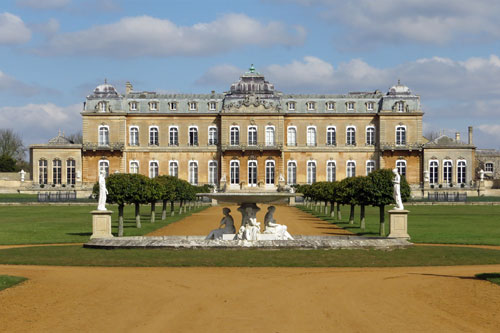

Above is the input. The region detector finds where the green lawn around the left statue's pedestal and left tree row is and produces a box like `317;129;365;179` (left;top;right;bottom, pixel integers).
0;205;204;245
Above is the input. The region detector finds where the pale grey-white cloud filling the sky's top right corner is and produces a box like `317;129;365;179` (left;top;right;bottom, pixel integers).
274;0;500;48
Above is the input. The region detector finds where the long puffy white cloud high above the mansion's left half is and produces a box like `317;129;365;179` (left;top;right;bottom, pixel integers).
37;14;306;57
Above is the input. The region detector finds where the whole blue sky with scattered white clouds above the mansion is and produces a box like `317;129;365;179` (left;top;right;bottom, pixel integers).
0;0;500;149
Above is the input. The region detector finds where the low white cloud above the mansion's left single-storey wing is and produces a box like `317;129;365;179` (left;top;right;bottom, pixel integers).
0;103;82;145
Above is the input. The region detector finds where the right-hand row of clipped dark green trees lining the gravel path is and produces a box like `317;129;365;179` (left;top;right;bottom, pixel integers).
297;169;411;236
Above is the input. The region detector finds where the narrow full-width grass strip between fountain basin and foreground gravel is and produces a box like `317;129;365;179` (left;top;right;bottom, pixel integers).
0;246;500;267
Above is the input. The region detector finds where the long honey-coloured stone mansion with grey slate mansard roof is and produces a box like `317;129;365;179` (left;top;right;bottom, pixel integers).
30;66;475;190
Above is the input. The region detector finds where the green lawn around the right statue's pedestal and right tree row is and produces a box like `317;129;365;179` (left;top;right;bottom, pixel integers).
299;205;500;245
